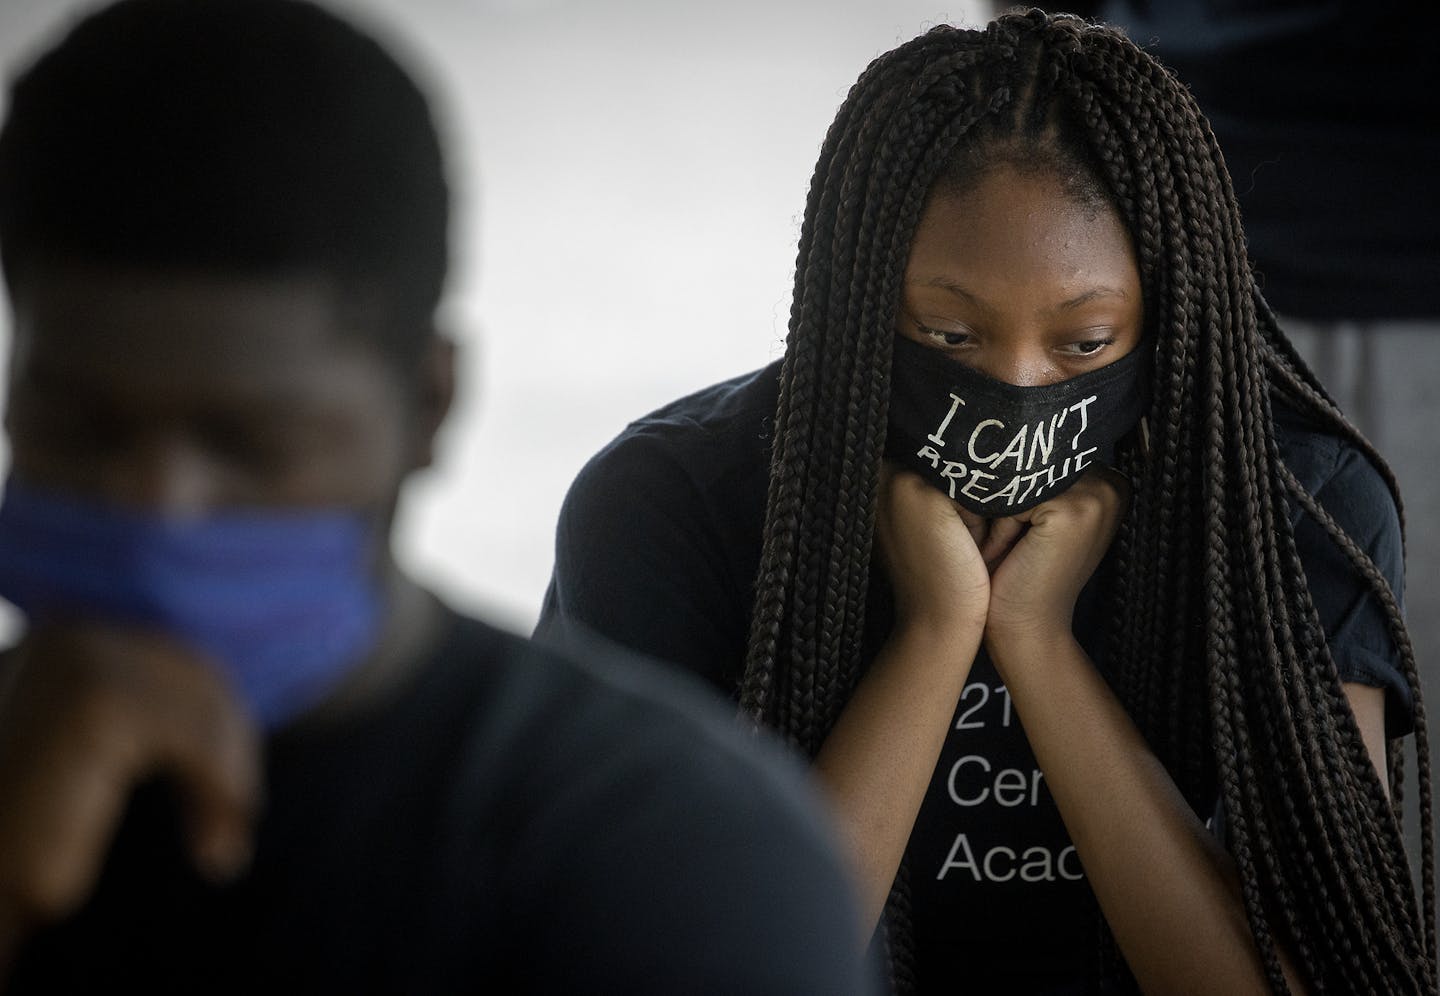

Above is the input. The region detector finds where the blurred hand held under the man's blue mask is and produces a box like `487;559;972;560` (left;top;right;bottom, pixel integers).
0;623;262;982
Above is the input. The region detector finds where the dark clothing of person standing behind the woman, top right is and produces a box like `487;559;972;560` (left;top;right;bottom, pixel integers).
1088;0;1440;320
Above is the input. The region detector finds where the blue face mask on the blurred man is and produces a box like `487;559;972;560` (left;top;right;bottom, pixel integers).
0;478;382;728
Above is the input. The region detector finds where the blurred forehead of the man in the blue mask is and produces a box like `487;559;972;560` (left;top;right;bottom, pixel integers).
12;266;382;396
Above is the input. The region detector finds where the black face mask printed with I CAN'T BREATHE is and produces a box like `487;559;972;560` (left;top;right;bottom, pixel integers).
886;335;1151;518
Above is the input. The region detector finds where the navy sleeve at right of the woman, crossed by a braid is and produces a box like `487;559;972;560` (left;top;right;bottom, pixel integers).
1286;436;1414;737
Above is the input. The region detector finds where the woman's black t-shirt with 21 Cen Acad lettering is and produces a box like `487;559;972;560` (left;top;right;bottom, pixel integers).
537;363;1411;993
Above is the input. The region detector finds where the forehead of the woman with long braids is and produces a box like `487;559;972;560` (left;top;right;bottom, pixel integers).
907;167;1139;294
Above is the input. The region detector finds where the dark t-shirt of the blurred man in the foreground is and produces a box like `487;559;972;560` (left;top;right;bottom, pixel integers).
7;616;876;996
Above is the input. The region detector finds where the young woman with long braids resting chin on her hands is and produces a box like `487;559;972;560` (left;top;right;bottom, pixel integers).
539;12;1436;993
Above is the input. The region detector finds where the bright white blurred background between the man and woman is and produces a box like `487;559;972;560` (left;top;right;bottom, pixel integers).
0;0;981;629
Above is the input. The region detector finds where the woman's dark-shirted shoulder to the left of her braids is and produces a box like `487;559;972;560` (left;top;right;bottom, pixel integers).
536;363;779;694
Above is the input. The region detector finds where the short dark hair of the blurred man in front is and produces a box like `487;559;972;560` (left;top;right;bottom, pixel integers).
0;0;449;364
